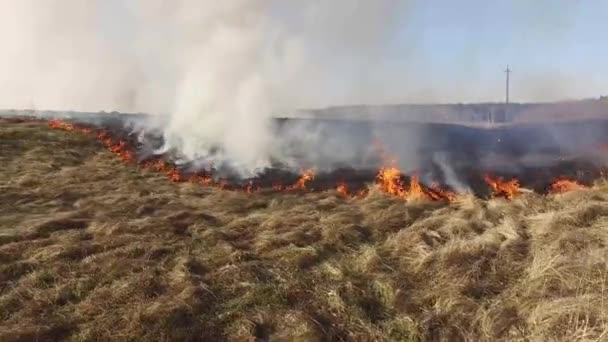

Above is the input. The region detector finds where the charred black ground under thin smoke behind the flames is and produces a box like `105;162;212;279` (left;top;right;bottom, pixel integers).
4;114;608;197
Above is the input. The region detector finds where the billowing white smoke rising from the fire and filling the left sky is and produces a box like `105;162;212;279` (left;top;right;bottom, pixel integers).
0;0;414;172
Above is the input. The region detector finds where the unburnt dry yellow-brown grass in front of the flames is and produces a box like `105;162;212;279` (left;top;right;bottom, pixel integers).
0;122;608;341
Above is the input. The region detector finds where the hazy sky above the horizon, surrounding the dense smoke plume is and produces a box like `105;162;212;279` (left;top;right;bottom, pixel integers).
0;0;608;112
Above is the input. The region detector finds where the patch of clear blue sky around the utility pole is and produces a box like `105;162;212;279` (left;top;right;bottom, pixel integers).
387;0;608;101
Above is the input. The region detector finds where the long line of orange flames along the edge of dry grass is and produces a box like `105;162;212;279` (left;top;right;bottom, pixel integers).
5;113;606;201
